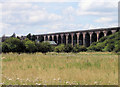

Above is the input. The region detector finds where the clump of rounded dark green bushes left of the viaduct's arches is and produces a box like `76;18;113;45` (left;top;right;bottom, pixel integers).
2;37;53;53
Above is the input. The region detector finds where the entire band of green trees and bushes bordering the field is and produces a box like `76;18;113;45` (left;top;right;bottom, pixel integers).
2;31;120;53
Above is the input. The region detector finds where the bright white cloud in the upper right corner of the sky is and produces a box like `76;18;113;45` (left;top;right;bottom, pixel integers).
76;0;118;16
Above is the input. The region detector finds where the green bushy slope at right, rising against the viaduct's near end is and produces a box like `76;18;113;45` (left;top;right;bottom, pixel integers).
87;31;120;52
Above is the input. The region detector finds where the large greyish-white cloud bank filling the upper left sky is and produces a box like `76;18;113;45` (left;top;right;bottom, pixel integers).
3;3;62;25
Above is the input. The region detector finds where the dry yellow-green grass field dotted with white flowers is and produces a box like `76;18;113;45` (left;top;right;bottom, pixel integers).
2;52;118;85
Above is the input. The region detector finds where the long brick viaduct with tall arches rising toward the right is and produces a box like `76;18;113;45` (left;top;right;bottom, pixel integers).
36;27;120;47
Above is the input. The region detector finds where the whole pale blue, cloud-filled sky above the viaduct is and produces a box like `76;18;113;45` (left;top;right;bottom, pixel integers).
0;0;119;36
